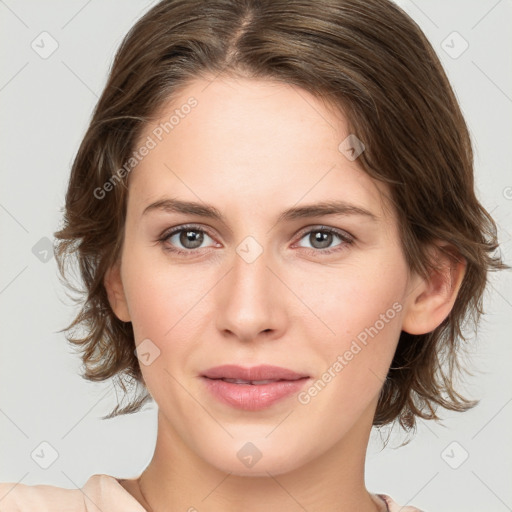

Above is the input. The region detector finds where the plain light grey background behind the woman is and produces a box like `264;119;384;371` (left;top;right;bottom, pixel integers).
0;0;512;512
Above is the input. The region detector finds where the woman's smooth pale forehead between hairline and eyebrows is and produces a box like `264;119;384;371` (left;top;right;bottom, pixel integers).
130;78;387;226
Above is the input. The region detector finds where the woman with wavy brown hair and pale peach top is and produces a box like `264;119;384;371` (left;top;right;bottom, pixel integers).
0;0;505;512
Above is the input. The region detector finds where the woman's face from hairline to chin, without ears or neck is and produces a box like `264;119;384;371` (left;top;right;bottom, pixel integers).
109;78;420;475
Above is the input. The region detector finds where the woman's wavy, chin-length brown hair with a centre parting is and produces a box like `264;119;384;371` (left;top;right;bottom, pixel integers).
55;0;508;430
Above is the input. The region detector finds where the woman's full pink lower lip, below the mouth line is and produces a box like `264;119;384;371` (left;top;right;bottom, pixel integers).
203;377;309;411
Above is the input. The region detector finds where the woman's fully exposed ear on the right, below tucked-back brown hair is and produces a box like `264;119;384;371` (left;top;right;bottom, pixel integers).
402;242;466;334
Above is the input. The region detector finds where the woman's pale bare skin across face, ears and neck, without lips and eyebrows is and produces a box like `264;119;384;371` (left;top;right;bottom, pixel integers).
104;77;465;512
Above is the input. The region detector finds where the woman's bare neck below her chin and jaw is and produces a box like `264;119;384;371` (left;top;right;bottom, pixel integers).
134;404;385;512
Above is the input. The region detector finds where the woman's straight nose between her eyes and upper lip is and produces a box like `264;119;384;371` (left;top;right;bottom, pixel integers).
216;244;287;342
